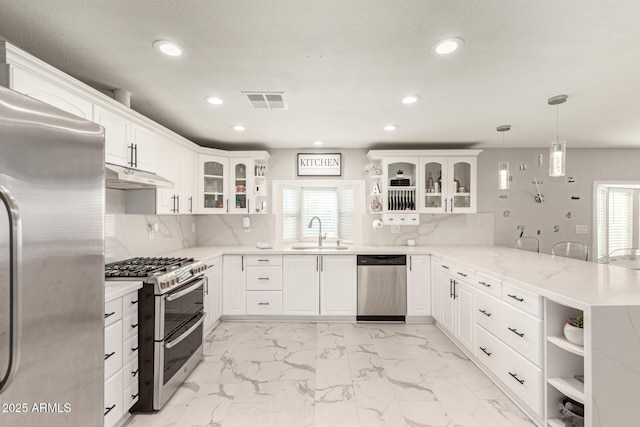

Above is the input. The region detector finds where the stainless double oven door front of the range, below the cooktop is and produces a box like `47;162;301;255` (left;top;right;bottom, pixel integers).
153;278;205;410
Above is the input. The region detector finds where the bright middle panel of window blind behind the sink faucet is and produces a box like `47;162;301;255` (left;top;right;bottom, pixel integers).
302;188;338;240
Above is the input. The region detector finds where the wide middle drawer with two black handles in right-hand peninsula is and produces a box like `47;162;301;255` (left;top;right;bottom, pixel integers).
476;293;542;366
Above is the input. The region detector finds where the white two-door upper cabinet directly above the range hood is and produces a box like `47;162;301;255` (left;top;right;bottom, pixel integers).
93;105;159;173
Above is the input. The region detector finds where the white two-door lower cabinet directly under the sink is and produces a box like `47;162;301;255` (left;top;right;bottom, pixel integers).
283;255;358;316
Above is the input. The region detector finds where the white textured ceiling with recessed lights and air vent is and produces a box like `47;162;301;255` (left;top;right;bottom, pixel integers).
0;0;640;149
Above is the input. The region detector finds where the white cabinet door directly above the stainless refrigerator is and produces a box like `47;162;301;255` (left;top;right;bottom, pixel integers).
10;67;93;120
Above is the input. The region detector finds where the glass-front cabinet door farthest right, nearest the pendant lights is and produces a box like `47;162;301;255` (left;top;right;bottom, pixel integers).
448;157;477;213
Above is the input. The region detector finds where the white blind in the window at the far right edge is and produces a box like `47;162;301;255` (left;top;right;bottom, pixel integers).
607;188;633;253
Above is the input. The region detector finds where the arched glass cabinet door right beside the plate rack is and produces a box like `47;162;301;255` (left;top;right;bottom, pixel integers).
420;157;449;213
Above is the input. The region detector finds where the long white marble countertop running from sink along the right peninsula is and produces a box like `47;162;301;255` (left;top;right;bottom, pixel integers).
159;245;640;309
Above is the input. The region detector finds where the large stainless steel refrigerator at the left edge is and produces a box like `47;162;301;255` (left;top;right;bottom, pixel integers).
0;87;105;427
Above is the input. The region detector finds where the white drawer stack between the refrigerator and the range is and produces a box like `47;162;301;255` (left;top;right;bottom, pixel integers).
104;291;139;427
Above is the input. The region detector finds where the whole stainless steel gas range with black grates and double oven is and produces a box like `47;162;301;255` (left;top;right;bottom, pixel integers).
105;258;206;412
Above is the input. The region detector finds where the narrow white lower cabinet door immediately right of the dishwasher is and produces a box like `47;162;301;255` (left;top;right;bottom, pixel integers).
407;255;431;317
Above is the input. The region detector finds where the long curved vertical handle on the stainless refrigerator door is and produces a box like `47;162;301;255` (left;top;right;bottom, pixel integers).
0;185;22;394
